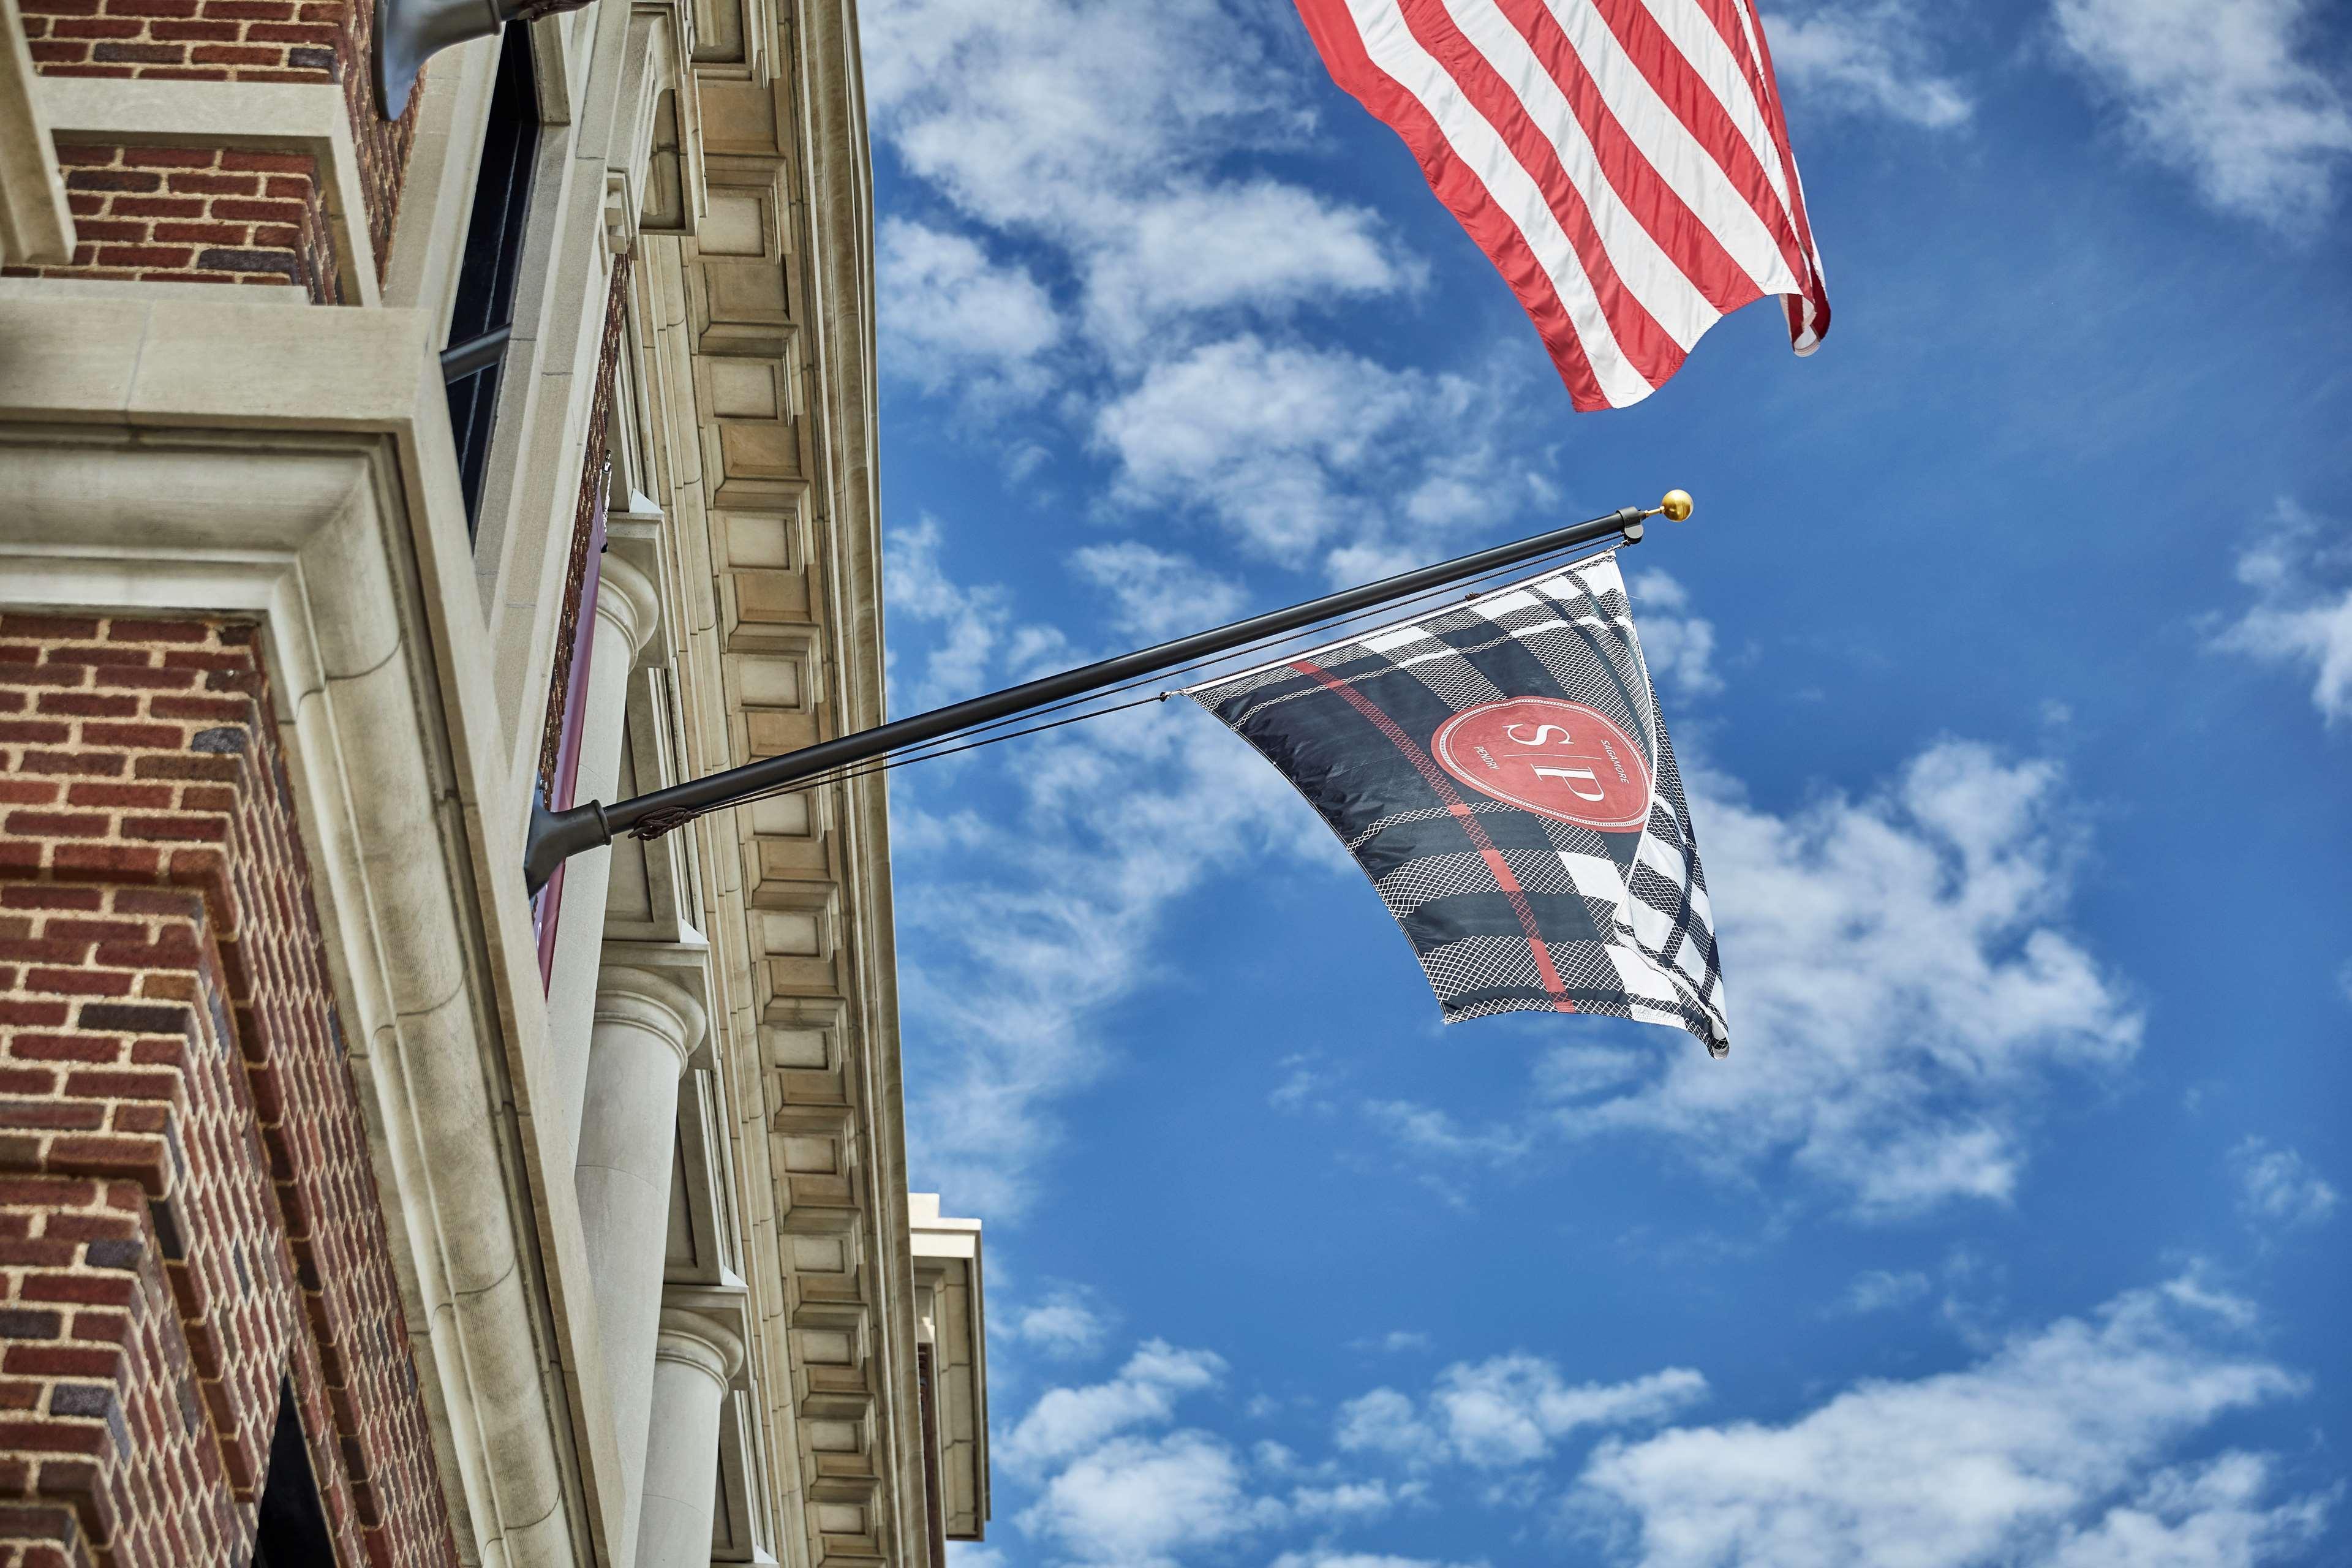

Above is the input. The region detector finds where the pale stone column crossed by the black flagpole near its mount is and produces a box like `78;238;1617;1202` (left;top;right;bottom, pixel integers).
548;550;661;1166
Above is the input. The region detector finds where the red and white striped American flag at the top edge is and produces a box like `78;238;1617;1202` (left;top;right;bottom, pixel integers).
1298;0;1830;409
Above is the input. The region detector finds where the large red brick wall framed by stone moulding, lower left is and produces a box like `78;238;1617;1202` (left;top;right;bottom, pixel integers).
0;616;454;1568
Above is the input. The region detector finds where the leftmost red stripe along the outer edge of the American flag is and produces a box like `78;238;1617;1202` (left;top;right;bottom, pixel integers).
1298;0;1611;414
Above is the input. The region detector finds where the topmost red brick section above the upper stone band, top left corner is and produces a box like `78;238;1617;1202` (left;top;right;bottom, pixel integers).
21;0;417;277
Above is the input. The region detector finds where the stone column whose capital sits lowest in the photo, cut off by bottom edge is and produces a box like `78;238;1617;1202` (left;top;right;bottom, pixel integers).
638;1307;743;1568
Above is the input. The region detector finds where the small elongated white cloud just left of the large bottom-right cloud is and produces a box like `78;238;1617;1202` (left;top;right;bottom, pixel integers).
1333;1352;1708;1469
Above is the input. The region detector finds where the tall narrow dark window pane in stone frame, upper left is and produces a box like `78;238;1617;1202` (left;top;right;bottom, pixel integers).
442;23;538;536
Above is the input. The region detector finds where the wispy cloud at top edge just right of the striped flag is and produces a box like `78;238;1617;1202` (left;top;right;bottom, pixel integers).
1766;0;1976;129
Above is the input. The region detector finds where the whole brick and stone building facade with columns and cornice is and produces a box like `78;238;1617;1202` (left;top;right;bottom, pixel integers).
0;0;988;1568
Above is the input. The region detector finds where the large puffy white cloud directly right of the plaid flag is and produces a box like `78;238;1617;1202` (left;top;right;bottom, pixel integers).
1538;743;2140;1213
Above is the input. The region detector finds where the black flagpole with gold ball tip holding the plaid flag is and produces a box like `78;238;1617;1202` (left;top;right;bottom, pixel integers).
522;489;1691;895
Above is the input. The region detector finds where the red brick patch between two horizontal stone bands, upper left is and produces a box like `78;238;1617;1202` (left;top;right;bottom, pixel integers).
7;143;344;306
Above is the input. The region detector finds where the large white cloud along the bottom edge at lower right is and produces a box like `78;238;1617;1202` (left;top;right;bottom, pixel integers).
1580;1291;2326;1568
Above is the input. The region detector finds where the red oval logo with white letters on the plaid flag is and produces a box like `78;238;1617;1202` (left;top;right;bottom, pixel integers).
1430;696;1649;832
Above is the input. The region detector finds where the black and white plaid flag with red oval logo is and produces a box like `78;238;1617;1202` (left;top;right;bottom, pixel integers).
1185;550;1731;1055
